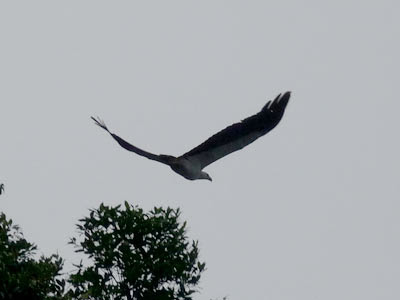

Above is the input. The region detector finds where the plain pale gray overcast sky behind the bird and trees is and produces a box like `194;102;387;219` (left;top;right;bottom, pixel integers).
0;0;400;300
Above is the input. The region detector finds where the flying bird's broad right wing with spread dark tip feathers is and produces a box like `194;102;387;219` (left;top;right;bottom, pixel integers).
182;92;290;168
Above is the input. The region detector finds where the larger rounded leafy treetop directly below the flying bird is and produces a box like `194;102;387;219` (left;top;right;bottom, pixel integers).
70;202;205;300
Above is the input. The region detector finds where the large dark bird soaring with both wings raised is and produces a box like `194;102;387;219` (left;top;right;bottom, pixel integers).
91;92;290;181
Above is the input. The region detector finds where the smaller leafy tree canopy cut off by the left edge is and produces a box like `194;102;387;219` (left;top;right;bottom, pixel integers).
0;213;65;300
